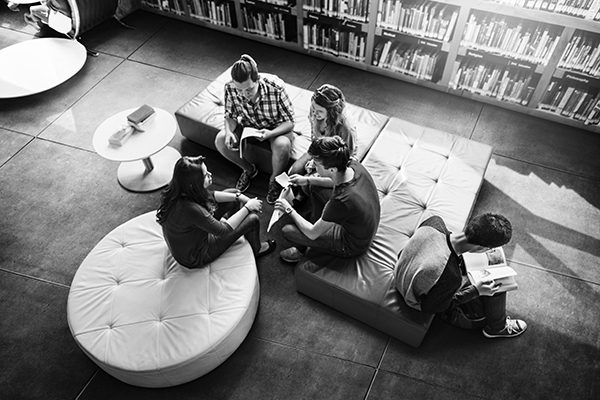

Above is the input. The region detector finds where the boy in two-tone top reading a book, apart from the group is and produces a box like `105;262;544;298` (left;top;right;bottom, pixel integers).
395;213;527;338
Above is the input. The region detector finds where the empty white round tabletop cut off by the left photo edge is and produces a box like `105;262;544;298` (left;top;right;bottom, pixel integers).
0;38;86;99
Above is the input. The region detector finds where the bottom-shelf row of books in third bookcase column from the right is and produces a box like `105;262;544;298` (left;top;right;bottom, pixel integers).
373;40;445;81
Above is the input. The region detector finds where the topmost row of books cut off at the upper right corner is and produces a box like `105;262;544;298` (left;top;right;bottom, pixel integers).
488;0;600;20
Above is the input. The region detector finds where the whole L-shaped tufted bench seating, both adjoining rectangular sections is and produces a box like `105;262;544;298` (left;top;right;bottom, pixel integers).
175;70;492;347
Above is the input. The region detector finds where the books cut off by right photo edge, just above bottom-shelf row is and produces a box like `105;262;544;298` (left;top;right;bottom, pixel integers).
558;32;600;77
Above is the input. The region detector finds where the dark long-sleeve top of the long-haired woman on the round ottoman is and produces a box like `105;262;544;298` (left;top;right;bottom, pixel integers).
162;198;233;268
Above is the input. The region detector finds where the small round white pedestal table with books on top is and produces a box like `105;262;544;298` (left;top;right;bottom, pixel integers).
93;108;181;192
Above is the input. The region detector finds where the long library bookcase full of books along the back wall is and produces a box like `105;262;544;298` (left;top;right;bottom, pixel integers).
142;0;600;133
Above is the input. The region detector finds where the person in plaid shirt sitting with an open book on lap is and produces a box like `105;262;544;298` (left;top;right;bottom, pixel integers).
215;54;294;204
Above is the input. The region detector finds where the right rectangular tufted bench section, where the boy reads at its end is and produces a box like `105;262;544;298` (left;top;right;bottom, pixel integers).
295;118;492;347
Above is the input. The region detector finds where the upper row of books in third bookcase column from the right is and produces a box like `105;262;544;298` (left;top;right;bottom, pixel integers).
377;0;459;42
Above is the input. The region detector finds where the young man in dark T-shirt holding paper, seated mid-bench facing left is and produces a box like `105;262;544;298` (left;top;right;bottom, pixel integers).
275;136;381;262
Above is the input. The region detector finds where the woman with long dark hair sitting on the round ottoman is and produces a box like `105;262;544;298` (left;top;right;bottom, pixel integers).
156;156;276;268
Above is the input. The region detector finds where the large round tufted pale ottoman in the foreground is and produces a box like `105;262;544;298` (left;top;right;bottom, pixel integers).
67;211;259;387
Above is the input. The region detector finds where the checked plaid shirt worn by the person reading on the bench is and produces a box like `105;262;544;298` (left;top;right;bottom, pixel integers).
225;75;294;129
